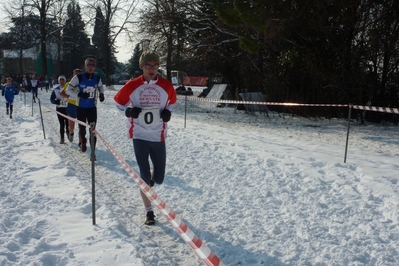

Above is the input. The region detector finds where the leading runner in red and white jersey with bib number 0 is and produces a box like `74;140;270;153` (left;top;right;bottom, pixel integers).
114;52;176;225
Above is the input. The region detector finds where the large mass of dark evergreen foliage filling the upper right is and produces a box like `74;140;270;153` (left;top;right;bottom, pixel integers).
212;0;399;118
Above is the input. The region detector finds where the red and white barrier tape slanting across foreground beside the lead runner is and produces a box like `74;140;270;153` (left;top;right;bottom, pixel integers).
40;100;224;266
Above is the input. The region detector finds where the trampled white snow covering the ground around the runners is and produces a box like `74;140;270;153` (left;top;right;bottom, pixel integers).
0;87;399;266
